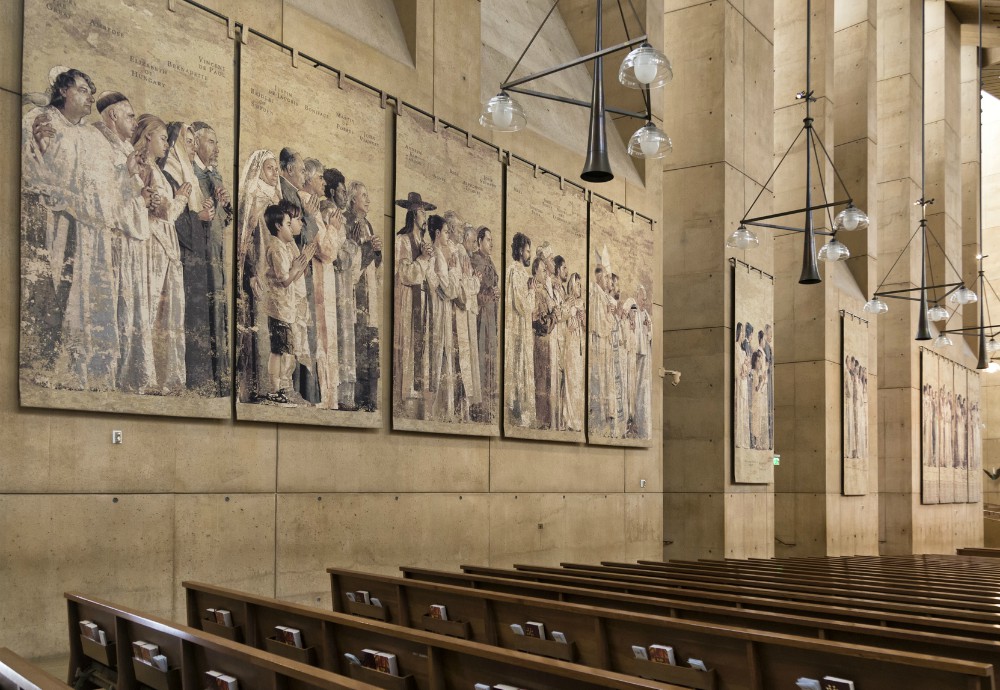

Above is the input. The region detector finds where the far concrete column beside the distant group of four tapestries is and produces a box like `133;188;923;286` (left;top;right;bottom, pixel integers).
877;0;982;554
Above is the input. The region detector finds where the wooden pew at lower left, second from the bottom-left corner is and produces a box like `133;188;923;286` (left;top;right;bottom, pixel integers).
66;592;379;690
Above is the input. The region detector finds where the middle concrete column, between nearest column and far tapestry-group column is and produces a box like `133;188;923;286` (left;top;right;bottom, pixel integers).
774;0;878;556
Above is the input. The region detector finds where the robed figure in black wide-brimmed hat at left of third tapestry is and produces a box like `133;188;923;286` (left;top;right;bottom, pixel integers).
392;192;437;418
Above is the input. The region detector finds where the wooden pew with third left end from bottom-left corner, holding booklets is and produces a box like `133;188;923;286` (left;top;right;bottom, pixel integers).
183;582;688;690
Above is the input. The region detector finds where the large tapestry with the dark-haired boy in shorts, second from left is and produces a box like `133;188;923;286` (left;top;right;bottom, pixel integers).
236;41;390;427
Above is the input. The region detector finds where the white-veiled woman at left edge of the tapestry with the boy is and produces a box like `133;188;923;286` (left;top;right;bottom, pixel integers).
236;149;281;402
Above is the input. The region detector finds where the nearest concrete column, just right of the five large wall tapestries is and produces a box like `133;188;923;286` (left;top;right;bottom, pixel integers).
663;0;774;558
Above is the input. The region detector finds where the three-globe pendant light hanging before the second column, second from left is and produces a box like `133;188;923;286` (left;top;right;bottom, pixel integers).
726;0;868;285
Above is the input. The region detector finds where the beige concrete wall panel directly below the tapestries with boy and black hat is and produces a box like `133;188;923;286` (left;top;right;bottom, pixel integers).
278;426;488;492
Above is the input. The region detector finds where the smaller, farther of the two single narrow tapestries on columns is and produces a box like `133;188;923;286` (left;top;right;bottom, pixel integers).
841;312;870;496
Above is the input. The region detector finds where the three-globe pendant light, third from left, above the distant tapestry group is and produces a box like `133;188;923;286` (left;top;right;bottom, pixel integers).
864;0;982;336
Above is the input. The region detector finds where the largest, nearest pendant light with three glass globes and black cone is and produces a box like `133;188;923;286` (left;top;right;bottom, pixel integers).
479;0;674;182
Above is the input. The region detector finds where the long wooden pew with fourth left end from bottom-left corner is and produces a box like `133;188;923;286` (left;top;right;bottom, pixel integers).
327;568;1000;686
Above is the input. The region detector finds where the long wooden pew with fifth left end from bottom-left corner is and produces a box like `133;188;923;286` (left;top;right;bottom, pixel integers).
400;567;998;640
